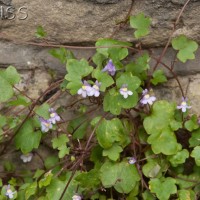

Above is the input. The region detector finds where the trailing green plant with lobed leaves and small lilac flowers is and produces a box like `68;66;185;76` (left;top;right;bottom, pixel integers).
0;13;200;200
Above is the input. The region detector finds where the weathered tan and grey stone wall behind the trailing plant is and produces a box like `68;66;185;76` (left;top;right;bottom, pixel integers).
0;0;200;113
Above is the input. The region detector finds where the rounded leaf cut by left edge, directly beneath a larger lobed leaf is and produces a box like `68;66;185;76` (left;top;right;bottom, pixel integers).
0;76;14;102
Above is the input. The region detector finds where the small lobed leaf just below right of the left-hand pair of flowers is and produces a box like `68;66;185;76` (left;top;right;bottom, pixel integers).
52;134;69;158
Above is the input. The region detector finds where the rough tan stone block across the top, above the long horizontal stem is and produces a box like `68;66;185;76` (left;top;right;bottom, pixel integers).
0;0;200;46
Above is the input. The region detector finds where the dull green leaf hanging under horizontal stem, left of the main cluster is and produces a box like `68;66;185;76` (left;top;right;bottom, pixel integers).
49;47;75;64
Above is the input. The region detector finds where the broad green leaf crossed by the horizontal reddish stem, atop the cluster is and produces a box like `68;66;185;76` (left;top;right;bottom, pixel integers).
95;39;132;58
